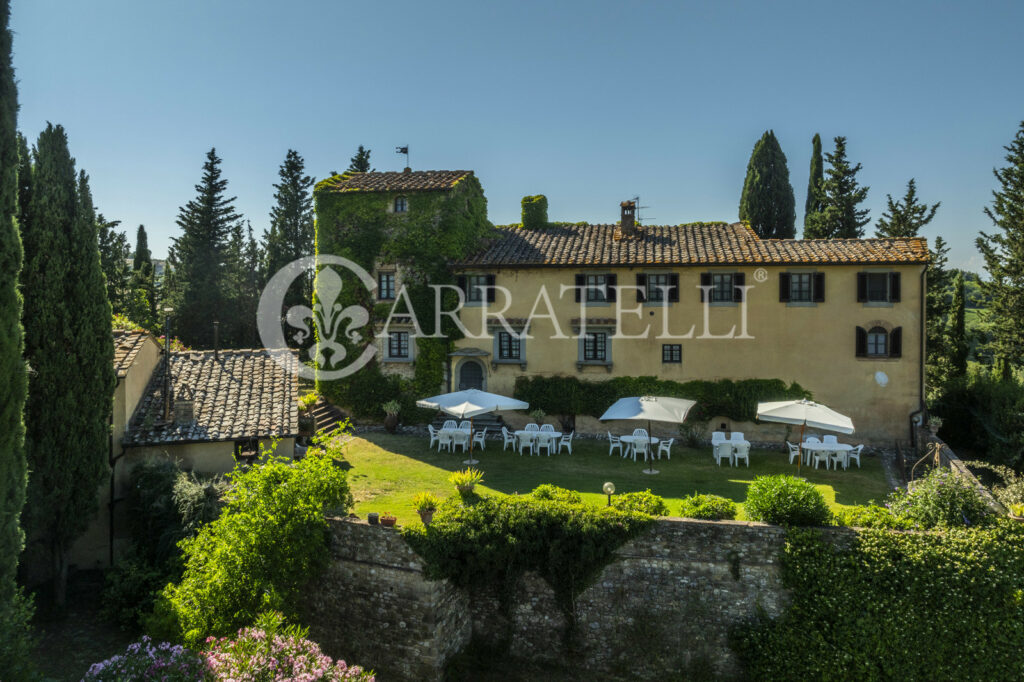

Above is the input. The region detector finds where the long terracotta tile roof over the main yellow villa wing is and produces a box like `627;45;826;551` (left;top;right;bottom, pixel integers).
460;222;929;267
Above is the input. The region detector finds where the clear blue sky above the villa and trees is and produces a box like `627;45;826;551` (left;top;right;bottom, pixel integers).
11;0;1024;269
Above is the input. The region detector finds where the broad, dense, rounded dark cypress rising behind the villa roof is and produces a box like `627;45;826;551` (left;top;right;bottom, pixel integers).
739;130;797;239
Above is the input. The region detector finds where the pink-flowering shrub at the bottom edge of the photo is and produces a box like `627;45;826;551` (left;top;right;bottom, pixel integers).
205;612;374;682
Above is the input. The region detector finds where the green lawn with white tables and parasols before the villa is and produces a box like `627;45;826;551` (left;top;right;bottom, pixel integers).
342;433;889;524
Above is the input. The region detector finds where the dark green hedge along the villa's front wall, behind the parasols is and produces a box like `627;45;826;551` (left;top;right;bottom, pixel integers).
513;377;811;422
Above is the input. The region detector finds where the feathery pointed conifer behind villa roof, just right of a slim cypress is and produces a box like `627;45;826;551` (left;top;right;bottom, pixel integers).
804;137;869;240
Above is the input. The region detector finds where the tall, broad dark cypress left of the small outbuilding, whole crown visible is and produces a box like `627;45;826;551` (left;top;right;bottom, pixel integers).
23;124;115;605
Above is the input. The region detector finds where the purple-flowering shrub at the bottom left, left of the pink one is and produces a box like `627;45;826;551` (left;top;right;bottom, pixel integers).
82;637;205;682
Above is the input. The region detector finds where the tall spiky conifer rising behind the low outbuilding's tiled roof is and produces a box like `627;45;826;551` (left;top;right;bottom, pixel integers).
164;148;242;348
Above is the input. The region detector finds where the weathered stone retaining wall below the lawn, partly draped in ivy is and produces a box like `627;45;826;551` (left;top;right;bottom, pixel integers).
305;518;823;681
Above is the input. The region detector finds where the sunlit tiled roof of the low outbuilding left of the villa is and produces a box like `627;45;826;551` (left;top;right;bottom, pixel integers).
124;349;299;445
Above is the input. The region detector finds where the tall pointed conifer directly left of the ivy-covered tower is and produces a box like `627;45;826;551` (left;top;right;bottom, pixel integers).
263;147;313;307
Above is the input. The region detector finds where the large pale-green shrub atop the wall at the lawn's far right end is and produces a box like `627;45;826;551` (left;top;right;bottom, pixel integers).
889;468;992;528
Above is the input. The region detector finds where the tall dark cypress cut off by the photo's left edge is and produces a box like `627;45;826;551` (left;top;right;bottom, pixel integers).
0;0;32;680
